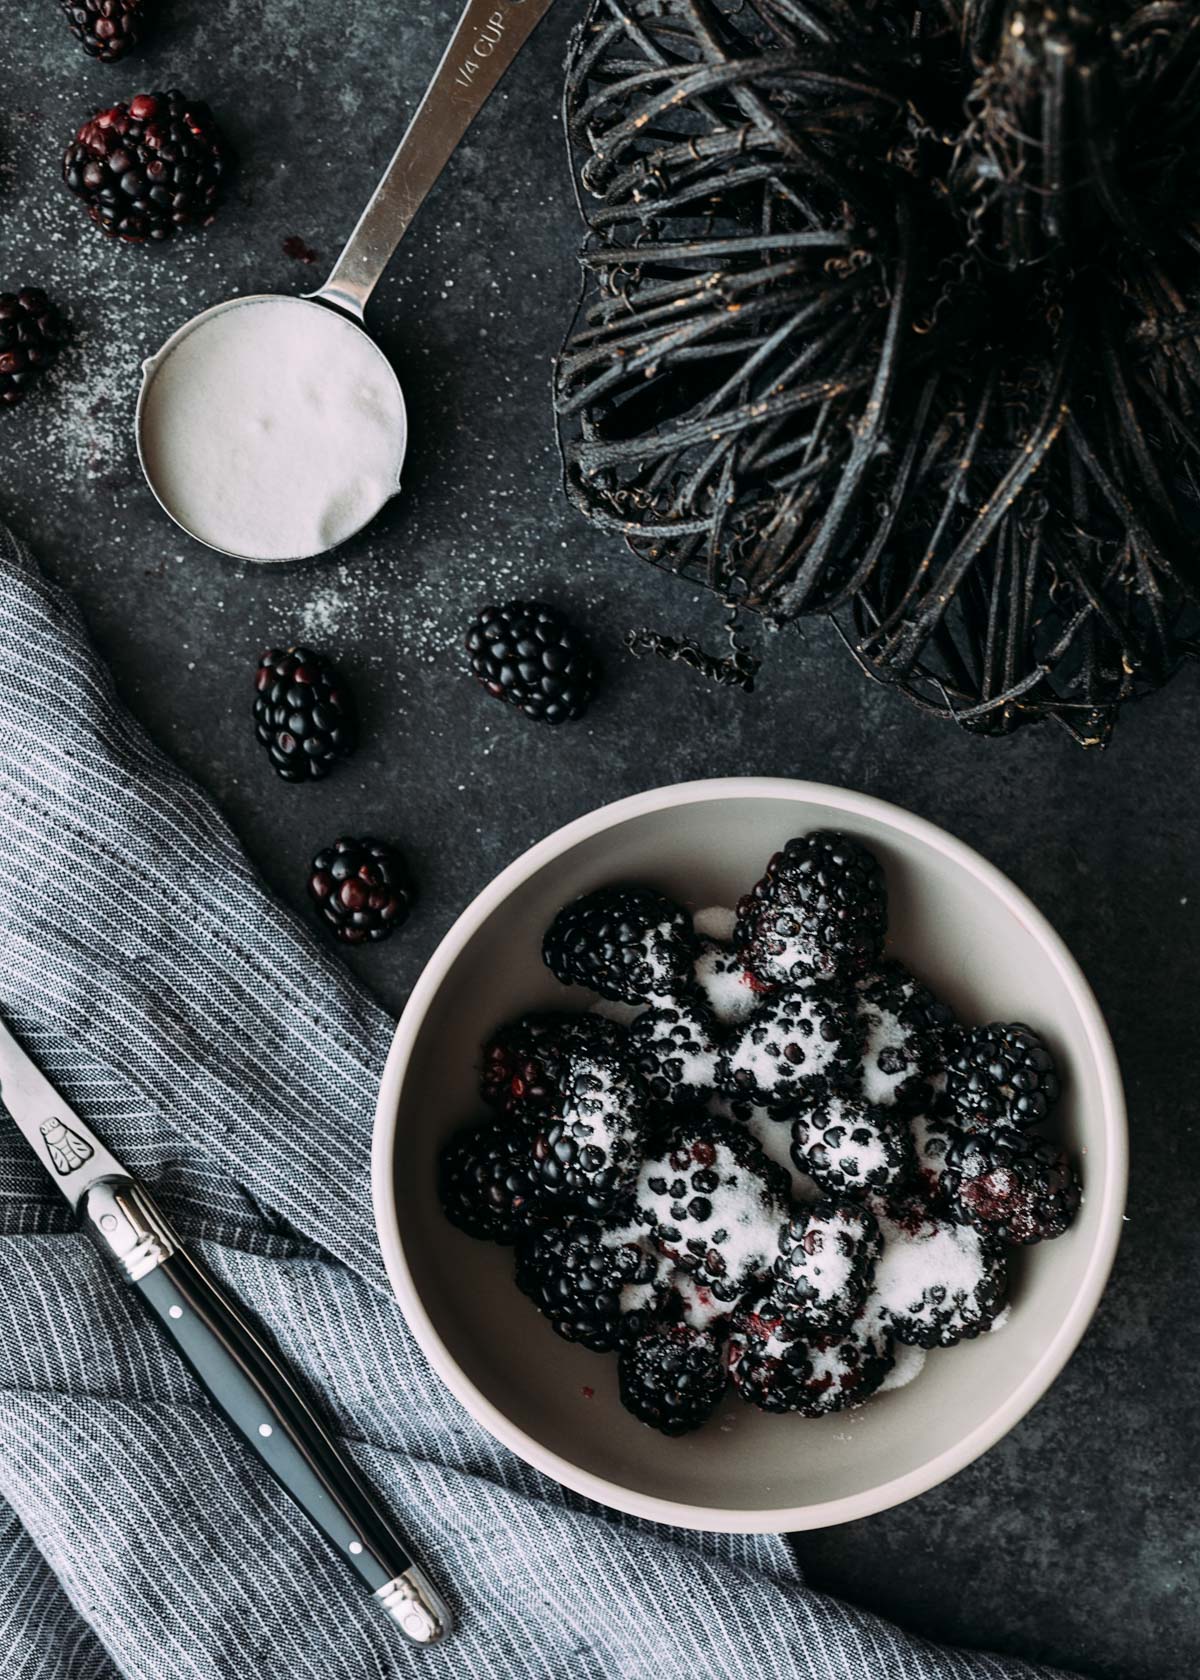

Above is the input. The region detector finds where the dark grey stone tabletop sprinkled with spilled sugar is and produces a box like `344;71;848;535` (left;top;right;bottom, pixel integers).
0;0;1200;1680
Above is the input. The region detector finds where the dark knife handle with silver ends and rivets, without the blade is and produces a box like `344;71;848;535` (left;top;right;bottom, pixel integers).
82;1179;452;1645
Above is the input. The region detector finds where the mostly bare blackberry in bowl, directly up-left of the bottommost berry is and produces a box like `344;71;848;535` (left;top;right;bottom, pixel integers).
516;1220;659;1354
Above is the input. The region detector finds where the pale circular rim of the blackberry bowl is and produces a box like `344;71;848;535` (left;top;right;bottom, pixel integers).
371;776;1128;1534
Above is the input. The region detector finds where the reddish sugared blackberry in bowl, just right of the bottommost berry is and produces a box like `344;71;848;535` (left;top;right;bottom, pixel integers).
729;1295;896;1418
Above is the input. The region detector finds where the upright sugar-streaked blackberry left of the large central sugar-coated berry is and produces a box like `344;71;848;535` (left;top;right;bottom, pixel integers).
533;1053;645;1213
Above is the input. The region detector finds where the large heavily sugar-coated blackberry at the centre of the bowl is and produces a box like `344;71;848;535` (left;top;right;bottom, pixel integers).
634;1119;788;1302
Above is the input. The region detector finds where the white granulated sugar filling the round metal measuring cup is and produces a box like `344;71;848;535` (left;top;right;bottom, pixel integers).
143;297;405;559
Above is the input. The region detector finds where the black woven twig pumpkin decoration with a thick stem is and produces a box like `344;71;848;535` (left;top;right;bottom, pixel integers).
556;0;1200;744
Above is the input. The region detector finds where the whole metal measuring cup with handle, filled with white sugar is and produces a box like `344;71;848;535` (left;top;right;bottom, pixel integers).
136;0;553;563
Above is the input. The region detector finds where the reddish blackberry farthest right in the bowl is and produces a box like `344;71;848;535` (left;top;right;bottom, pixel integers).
950;1127;1081;1243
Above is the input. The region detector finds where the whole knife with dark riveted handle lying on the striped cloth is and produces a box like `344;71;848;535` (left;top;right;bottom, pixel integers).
0;1021;454;1645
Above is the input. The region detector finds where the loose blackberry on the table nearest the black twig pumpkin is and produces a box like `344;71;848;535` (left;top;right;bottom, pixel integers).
466;601;600;724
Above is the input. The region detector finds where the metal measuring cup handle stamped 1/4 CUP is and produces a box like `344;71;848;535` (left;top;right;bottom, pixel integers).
308;0;553;321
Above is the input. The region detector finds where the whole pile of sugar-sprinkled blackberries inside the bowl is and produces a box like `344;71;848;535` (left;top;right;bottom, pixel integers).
440;830;1081;1435
